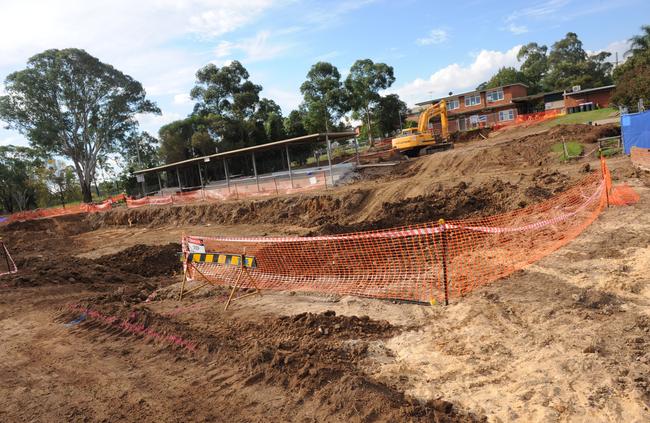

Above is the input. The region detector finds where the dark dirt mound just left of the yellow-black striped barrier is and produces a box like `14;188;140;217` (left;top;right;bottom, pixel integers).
94;243;182;277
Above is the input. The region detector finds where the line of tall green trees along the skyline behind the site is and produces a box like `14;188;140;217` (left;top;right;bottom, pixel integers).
0;25;650;212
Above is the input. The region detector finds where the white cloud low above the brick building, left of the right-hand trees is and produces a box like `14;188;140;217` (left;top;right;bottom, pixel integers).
389;45;521;106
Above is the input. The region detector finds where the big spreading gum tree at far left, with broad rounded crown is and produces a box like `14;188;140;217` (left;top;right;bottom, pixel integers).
0;49;160;202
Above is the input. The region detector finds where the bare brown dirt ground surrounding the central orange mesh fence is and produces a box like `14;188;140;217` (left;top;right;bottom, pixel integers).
0;121;650;422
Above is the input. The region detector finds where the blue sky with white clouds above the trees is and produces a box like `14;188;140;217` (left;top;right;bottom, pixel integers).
0;0;650;149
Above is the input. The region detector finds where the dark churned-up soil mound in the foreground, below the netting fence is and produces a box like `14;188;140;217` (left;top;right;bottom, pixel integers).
58;301;485;422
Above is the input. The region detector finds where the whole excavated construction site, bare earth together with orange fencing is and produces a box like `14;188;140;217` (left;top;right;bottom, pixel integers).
0;112;650;422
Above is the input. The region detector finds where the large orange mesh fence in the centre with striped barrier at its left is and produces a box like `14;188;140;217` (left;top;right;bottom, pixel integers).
182;161;632;303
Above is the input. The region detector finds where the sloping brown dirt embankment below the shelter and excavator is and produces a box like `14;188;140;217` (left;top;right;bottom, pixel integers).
87;125;616;234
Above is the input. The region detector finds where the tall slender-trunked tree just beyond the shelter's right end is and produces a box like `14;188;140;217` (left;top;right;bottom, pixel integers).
345;59;395;146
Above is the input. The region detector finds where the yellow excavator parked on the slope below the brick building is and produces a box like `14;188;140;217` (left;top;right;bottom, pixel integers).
392;100;454;157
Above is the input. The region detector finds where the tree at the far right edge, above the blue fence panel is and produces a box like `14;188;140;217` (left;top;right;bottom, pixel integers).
612;25;650;110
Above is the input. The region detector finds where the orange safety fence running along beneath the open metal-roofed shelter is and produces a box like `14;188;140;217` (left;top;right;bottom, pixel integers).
126;172;327;208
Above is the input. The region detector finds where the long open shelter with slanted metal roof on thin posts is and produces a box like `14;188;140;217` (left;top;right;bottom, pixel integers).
133;131;356;195
